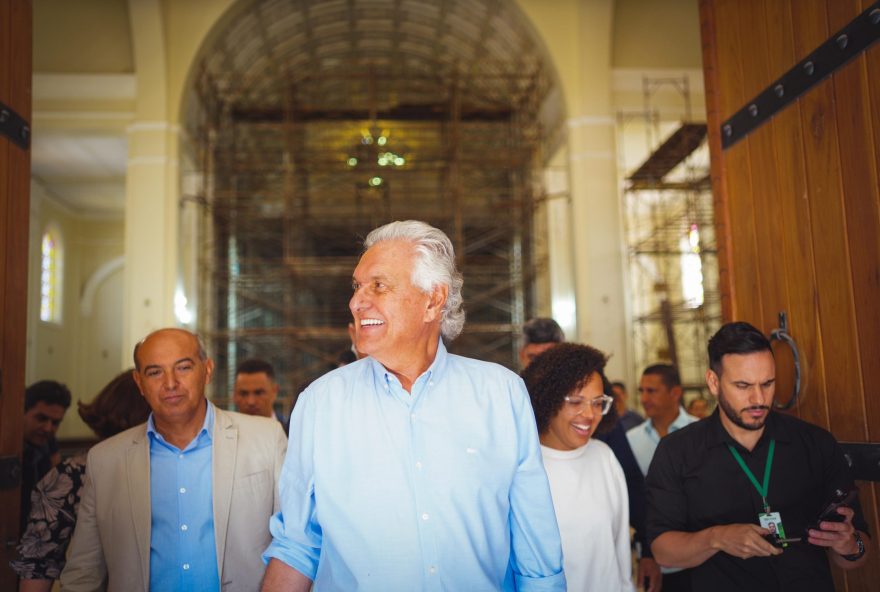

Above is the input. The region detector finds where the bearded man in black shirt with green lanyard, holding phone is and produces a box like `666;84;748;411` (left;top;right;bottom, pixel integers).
647;323;867;592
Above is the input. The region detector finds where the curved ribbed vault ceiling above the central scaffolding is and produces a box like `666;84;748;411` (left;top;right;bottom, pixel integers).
191;0;564;138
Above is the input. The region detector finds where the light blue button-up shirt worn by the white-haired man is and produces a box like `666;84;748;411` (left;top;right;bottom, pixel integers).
263;343;565;592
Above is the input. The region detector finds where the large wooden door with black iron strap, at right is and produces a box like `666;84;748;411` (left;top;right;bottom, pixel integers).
700;0;880;591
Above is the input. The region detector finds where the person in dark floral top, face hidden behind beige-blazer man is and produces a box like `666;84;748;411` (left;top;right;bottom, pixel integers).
10;370;150;592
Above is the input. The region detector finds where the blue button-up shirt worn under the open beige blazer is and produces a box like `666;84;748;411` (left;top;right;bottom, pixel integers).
147;403;220;592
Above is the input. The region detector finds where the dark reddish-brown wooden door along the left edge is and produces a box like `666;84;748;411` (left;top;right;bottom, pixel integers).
0;0;32;590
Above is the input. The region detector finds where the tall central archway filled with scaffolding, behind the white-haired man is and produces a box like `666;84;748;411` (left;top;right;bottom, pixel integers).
185;0;564;402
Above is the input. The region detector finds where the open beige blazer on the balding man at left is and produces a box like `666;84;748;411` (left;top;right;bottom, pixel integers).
61;403;287;592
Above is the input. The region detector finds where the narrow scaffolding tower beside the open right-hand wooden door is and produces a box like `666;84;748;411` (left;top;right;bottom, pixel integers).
619;77;721;397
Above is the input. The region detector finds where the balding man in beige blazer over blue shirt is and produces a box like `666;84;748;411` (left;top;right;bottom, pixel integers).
61;329;287;592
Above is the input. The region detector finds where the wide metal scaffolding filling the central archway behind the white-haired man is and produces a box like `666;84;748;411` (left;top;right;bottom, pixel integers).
189;2;558;408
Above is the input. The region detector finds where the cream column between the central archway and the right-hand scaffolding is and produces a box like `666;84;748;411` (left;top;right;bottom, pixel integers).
518;0;629;378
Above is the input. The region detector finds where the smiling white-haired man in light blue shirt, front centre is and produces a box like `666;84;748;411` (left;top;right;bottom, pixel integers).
263;221;565;591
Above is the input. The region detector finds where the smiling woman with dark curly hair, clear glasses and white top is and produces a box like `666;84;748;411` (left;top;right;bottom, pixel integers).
522;343;633;592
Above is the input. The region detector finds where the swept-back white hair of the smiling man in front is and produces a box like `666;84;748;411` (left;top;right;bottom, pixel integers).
364;220;464;341
